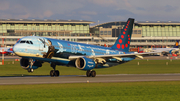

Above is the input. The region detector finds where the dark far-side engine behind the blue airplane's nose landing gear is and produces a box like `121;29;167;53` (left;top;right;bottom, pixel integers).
20;58;42;69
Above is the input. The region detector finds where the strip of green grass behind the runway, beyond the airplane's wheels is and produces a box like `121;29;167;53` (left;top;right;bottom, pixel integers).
0;60;180;76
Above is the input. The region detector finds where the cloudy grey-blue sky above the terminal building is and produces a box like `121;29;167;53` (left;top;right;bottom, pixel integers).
0;0;180;25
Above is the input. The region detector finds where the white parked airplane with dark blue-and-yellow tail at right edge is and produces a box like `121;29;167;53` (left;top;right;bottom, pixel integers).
144;40;179;56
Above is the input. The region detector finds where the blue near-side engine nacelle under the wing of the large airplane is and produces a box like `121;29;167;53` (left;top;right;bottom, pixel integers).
75;57;96;70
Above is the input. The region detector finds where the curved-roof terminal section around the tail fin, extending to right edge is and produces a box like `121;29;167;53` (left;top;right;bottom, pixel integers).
90;21;180;48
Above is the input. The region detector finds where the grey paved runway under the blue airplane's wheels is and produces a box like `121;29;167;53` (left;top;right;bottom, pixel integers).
0;74;180;85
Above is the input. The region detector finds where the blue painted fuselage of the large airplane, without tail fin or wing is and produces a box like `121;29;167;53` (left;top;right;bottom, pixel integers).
13;36;134;68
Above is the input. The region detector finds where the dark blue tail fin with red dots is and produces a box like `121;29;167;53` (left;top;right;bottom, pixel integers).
111;18;134;52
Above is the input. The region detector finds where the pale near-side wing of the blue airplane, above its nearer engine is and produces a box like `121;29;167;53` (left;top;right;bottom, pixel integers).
69;52;158;60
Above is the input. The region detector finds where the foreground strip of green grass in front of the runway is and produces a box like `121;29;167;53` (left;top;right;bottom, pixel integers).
0;81;180;101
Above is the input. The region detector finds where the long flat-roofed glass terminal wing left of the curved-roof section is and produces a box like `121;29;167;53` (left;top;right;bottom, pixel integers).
0;19;94;46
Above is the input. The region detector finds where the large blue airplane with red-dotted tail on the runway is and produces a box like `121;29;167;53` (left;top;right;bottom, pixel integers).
13;18;155;77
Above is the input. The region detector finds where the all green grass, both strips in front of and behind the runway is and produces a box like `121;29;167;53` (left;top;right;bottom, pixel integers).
0;60;180;101
